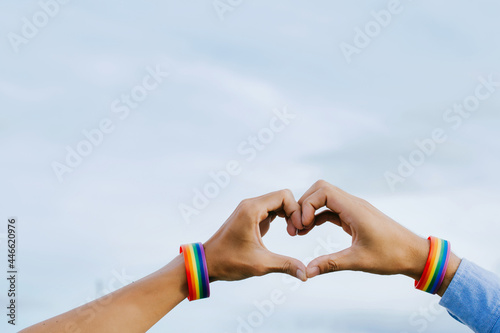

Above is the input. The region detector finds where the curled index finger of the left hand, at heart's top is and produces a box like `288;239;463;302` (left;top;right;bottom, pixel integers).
254;190;303;229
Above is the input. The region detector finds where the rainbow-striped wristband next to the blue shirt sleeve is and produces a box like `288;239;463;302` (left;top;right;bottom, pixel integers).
415;236;451;294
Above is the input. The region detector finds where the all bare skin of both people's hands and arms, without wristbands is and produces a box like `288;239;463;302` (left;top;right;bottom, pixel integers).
20;181;460;333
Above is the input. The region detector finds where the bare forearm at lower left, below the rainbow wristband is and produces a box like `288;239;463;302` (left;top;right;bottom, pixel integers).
21;255;188;333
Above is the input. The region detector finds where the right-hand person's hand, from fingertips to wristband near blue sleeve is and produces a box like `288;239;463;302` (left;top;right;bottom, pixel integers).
298;180;429;280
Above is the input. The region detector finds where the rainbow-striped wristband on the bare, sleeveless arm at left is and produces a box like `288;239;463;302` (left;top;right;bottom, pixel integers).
180;243;210;301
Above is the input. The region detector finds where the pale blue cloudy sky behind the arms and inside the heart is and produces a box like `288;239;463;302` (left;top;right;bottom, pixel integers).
0;0;500;333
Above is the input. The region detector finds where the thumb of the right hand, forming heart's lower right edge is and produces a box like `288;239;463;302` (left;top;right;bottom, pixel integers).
307;248;356;278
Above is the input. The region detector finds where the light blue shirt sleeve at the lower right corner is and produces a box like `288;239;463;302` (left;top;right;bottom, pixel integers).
439;258;500;333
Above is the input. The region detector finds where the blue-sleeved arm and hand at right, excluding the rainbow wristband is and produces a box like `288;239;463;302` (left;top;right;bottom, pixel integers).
296;181;500;332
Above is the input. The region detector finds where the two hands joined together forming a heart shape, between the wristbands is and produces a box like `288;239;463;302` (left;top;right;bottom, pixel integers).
204;181;436;281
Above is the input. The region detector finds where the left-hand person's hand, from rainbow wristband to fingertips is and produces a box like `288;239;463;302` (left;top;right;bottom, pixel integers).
204;190;307;281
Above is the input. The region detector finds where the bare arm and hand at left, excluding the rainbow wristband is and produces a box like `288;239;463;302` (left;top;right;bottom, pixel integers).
21;190;306;333
